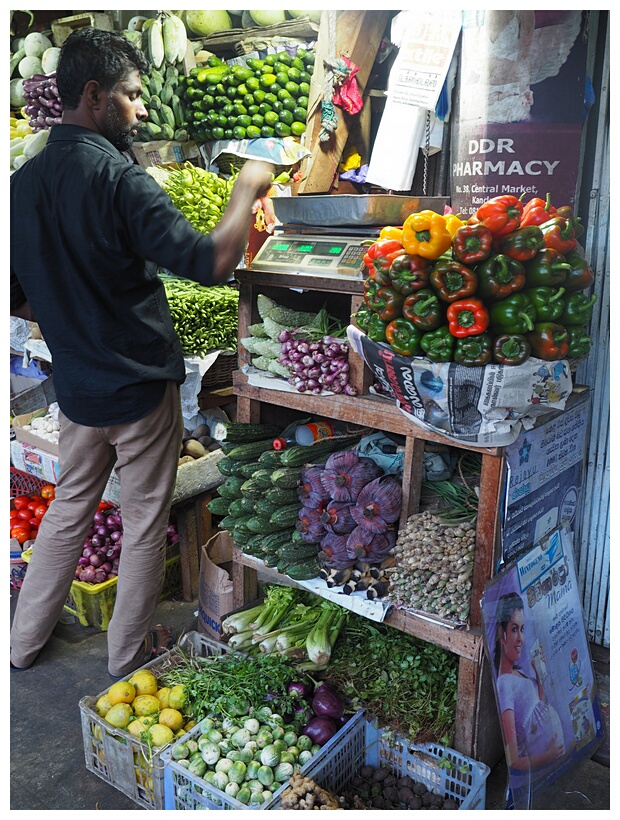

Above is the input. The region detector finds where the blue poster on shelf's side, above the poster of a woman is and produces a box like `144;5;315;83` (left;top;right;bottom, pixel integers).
502;395;589;563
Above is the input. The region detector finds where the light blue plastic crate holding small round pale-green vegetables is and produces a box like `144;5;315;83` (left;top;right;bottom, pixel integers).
161;712;365;811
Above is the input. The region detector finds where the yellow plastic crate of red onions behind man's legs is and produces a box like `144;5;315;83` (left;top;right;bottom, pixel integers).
22;546;183;632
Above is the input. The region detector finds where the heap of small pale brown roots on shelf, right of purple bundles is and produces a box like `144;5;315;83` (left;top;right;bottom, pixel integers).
389;510;476;621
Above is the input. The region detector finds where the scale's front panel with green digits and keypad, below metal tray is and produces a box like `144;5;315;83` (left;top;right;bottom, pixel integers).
252;235;368;277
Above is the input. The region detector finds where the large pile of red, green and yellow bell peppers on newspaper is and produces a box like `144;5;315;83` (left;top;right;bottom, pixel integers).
354;195;596;367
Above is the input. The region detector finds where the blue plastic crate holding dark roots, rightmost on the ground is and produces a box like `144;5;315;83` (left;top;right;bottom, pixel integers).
269;718;490;810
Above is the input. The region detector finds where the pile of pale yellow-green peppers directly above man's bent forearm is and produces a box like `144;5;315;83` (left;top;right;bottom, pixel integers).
151;162;236;233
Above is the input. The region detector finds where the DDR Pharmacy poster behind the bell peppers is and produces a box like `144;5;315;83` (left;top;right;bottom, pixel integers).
451;10;587;217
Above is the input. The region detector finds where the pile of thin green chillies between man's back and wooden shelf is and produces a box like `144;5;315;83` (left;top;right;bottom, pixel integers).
159;269;239;356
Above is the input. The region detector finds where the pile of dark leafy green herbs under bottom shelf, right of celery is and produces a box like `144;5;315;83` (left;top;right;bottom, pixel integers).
323;613;458;745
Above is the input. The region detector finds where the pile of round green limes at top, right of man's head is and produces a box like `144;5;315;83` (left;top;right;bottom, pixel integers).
181;48;314;143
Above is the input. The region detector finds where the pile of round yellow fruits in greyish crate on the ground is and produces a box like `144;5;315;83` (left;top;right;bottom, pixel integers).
95;669;194;747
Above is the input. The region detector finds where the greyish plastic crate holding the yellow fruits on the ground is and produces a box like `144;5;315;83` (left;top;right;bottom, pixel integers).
79;632;230;810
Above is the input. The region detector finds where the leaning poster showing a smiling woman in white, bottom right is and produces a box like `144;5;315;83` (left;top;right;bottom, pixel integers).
482;527;604;809
